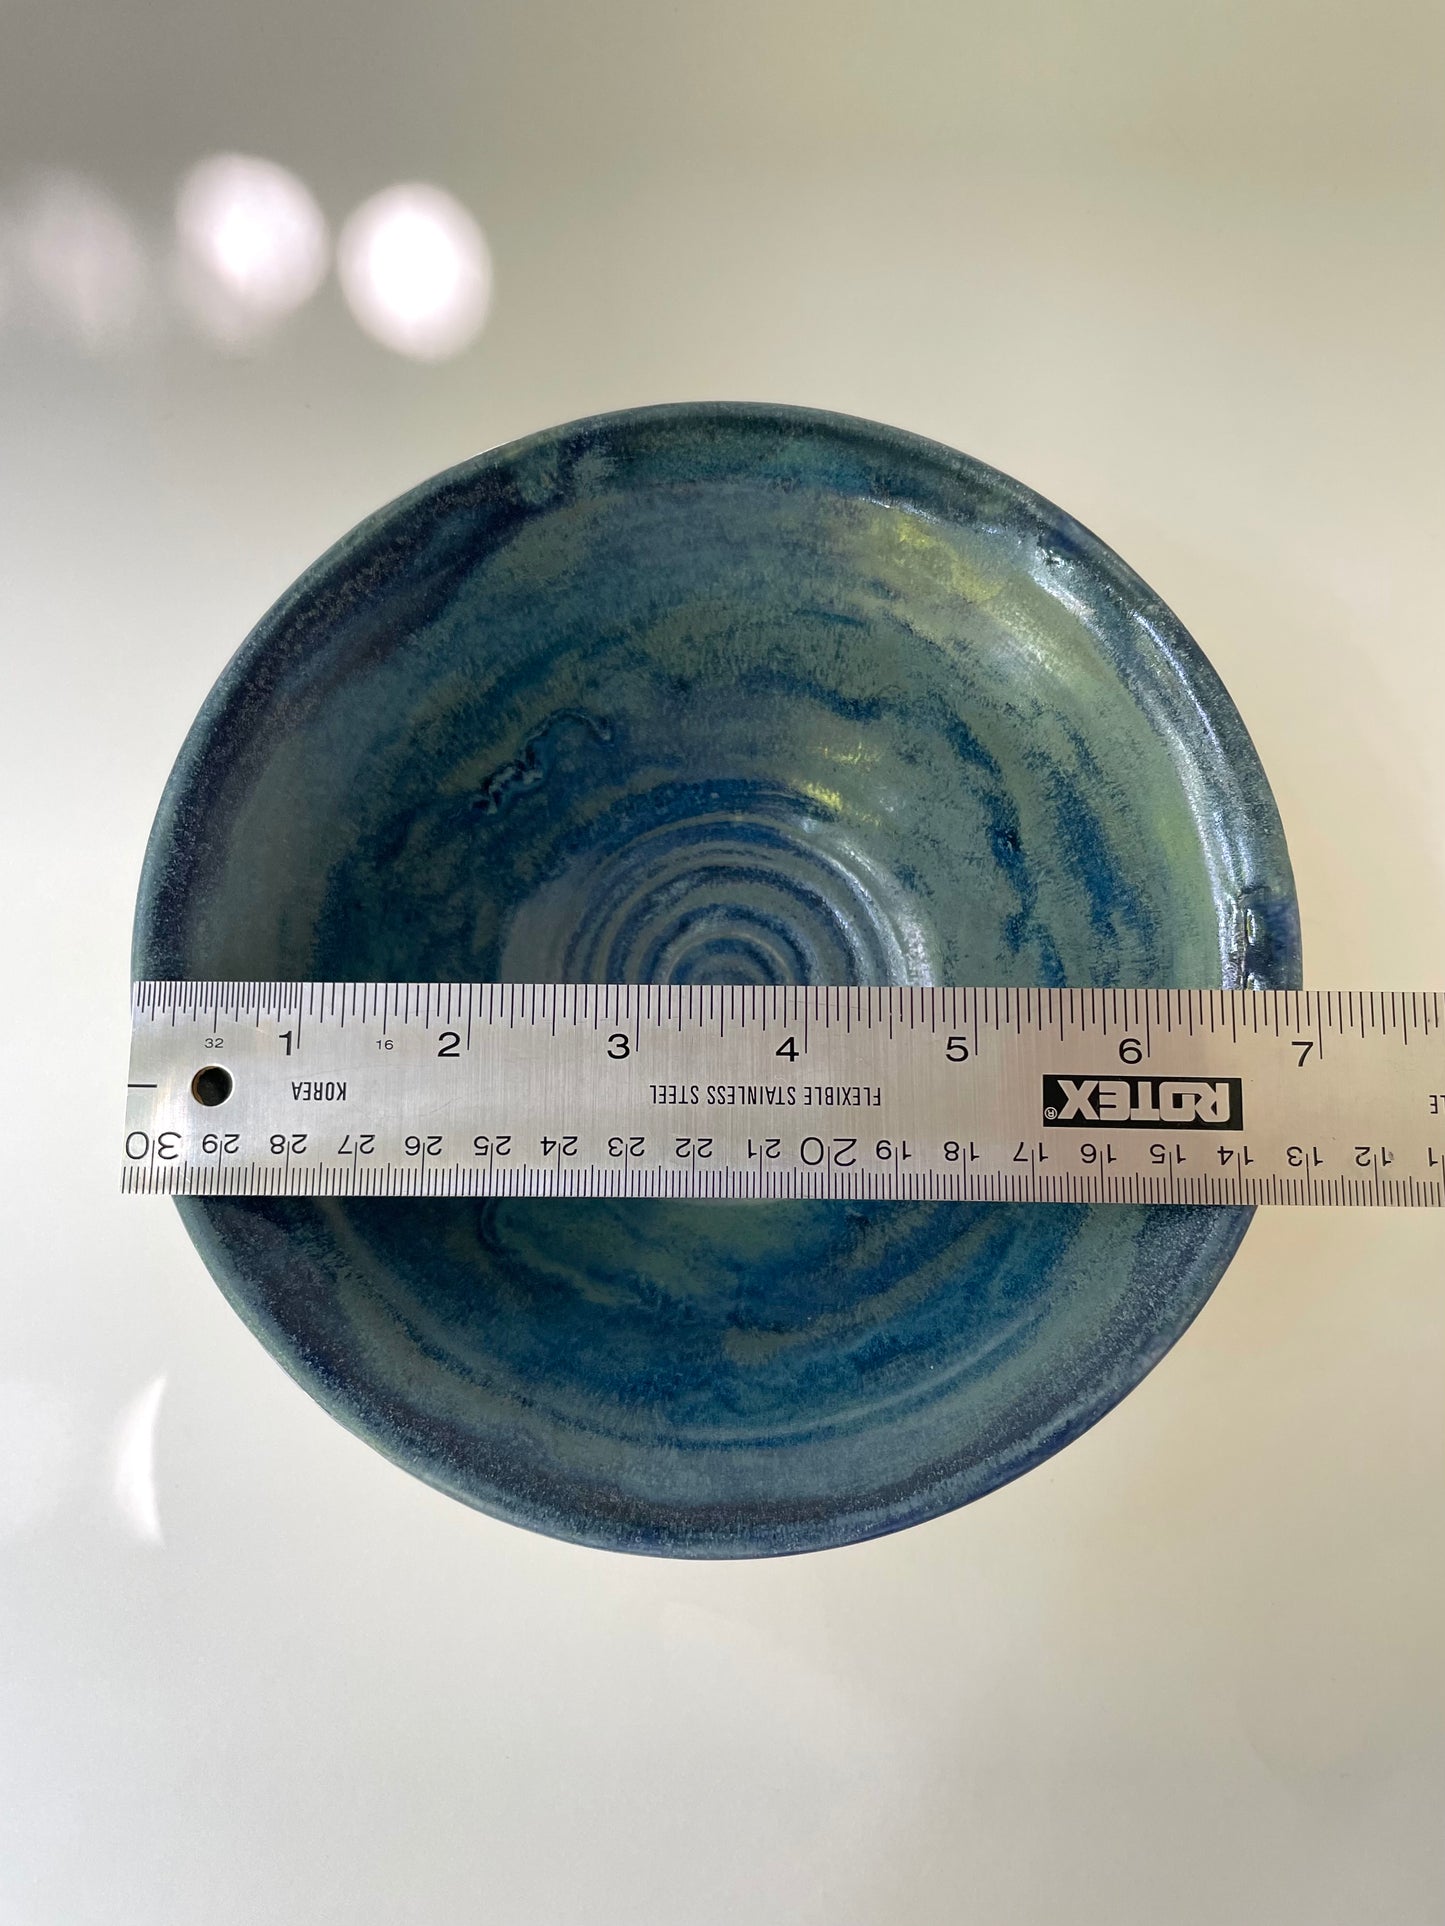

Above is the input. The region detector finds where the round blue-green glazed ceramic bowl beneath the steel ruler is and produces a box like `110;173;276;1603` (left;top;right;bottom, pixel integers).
135;404;1299;1556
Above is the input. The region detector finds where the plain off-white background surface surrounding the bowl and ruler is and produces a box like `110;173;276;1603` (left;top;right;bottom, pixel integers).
0;0;1445;1926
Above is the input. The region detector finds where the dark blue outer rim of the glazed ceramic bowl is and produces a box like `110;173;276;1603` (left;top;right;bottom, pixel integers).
133;401;1299;1556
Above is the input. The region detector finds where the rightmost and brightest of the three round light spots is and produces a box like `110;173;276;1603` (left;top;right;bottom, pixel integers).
337;183;491;360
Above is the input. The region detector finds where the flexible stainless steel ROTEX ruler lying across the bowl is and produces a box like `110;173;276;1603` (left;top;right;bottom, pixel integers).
121;980;1445;1208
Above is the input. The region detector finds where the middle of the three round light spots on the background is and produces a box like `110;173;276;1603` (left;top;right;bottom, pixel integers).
175;154;331;347
